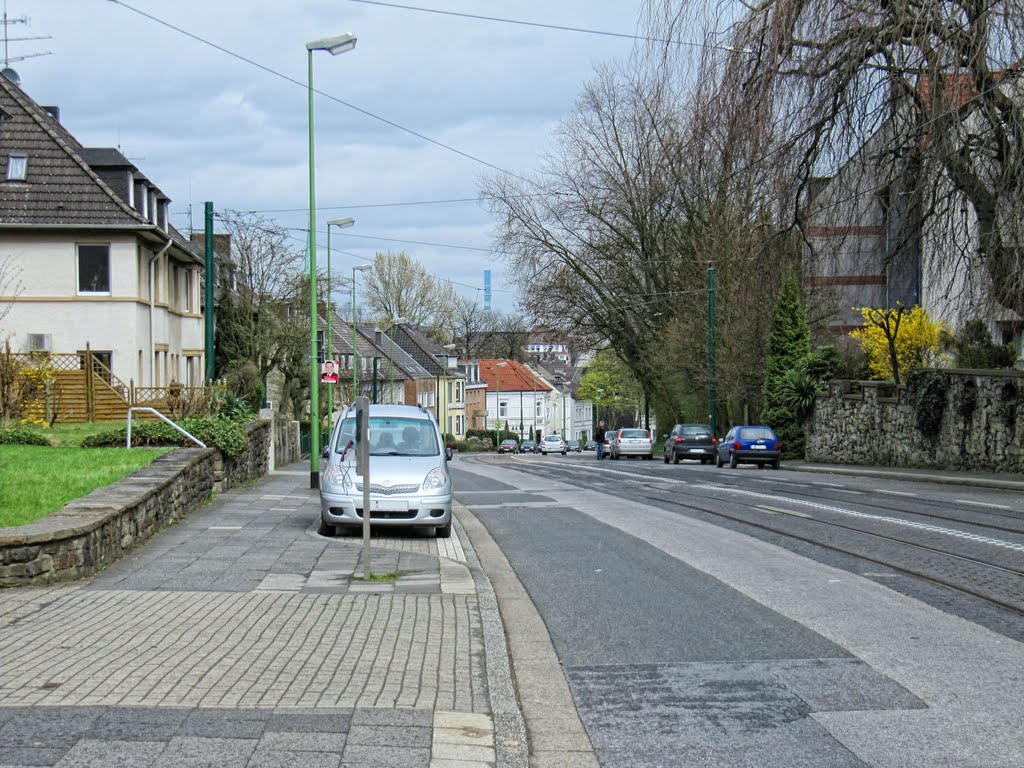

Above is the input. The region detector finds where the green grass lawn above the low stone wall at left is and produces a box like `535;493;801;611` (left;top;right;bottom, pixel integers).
0;444;173;527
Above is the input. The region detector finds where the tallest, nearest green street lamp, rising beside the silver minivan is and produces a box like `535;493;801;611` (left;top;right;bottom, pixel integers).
306;35;355;488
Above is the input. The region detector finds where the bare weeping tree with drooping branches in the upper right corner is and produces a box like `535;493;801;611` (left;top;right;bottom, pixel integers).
708;0;1024;316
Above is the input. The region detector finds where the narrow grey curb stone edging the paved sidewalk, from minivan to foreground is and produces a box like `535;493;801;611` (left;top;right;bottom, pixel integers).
452;501;529;768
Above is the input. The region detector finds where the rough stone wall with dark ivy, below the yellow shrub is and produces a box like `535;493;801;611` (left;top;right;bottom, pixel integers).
807;371;1024;473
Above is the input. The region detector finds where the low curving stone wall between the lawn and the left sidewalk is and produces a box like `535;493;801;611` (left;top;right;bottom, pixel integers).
0;422;270;587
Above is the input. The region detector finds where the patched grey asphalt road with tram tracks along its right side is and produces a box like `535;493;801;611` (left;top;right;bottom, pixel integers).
453;455;1024;768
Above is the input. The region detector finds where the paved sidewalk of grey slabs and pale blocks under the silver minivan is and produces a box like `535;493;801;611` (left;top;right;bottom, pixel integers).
0;468;512;768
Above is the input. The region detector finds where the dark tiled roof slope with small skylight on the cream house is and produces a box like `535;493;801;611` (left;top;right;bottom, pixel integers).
0;77;150;228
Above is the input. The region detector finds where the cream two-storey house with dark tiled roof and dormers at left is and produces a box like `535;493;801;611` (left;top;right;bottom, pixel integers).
0;77;205;387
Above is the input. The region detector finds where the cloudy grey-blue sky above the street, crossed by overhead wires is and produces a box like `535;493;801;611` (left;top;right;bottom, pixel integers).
6;0;642;310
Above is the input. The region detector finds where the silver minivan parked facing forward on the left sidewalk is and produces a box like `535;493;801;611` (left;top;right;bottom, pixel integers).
319;403;453;539
